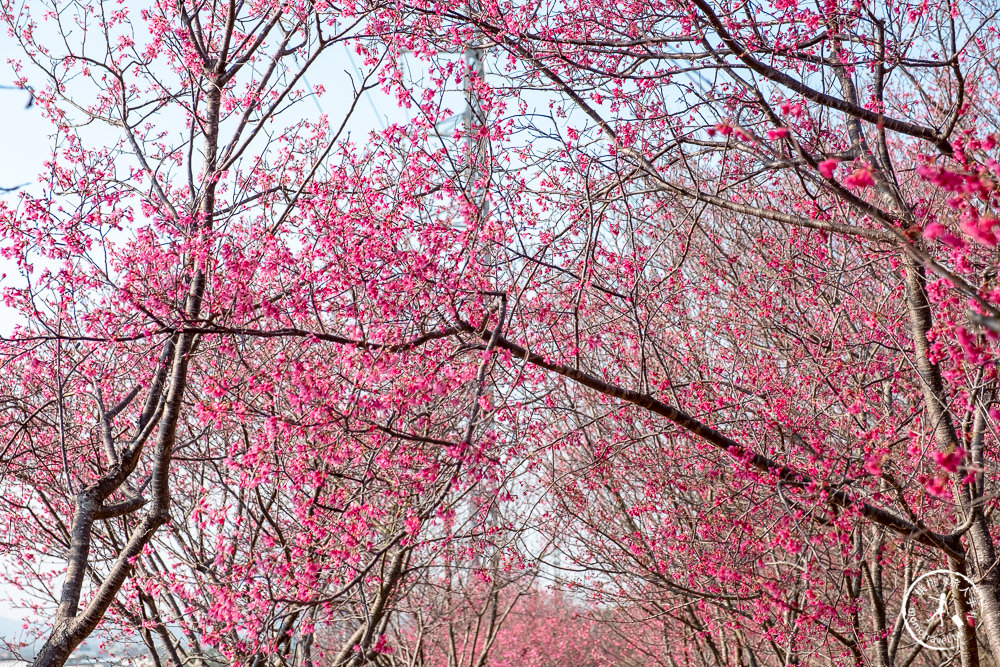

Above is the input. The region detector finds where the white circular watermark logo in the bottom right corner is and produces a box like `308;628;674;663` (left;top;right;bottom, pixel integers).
903;570;976;651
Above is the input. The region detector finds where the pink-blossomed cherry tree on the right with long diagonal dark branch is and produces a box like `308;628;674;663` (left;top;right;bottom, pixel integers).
410;2;1000;664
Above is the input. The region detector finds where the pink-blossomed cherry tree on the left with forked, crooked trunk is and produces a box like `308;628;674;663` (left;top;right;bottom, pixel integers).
3;2;500;665
